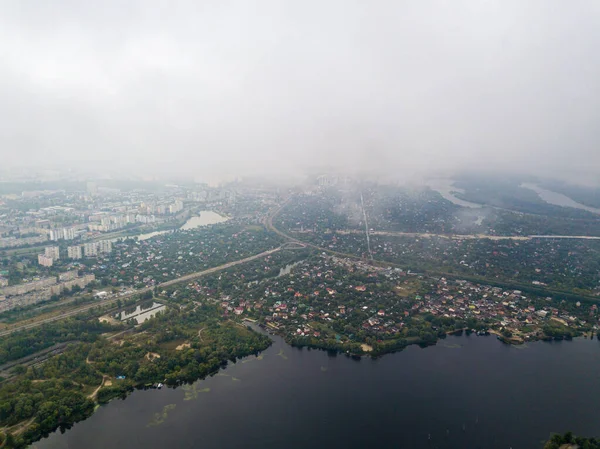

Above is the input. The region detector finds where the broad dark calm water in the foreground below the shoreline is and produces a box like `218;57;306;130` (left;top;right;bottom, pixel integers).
31;335;600;449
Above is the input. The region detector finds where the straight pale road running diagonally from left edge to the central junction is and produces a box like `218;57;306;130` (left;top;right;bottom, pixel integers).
0;247;281;337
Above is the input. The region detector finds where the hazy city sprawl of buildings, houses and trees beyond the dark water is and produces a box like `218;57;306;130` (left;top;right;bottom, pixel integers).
0;170;600;444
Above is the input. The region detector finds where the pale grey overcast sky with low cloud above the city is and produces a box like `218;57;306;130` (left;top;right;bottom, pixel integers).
0;0;600;180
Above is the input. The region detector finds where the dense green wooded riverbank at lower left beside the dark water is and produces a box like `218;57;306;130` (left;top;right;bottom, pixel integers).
0;305;271;448
